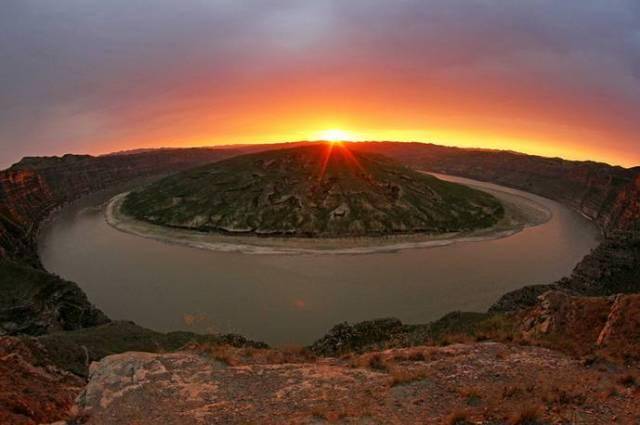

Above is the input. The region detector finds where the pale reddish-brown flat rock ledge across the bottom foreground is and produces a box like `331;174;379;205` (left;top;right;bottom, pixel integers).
78;343;640;425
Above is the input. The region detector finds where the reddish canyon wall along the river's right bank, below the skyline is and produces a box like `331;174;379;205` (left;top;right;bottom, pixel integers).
357;142;640;233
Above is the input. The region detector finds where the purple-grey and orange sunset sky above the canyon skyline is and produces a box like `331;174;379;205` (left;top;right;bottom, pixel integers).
0;0;640;168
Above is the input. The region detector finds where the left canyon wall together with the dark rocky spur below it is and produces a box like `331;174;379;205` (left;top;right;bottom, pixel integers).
0;149;236;335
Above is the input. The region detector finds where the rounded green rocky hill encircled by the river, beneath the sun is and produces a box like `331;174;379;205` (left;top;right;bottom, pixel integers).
122;143;504;237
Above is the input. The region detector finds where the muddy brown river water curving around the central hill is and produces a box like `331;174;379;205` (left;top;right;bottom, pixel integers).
40;178;599;345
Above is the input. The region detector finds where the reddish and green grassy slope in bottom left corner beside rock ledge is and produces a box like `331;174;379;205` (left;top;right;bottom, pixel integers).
0;322;267;425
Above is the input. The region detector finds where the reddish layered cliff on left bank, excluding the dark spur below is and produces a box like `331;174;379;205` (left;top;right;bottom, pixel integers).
0;149;237;265
